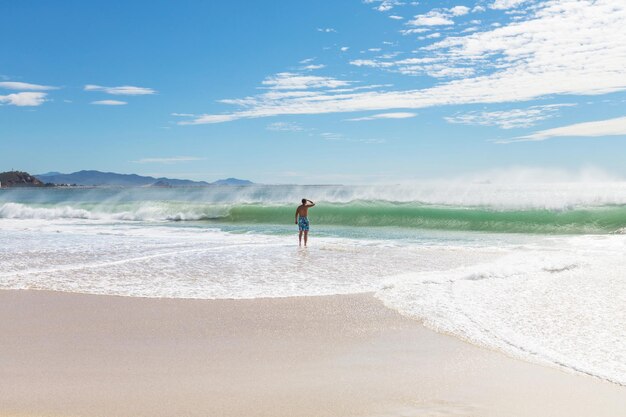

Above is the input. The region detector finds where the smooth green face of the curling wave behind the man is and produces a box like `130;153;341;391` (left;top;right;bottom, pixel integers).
218;202;626;234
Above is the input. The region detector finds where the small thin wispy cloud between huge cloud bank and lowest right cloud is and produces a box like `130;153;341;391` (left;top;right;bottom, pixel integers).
444;104;574;129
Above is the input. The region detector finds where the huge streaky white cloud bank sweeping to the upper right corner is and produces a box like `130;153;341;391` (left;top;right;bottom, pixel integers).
178;0;626;124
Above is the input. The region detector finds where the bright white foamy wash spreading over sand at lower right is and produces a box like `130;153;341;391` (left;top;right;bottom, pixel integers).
377;236;626;385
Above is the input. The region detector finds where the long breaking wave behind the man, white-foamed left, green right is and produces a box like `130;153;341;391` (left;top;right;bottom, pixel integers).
0;201;626;234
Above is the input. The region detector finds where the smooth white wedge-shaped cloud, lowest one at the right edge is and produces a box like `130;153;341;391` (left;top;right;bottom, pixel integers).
497;116;626;143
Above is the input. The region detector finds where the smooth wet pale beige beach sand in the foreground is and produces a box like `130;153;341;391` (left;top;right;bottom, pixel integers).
0;290;626;417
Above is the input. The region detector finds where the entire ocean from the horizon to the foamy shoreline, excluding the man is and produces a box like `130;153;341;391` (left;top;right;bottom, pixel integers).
0;182;626;385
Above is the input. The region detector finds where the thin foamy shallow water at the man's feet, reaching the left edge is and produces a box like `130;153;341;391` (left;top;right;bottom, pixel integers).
0;220;499;298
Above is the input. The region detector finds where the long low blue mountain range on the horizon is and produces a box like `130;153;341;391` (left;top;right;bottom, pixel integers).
36;170;253;187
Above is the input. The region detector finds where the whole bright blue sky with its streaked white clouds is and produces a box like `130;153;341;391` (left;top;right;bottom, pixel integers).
0;0;626;184
